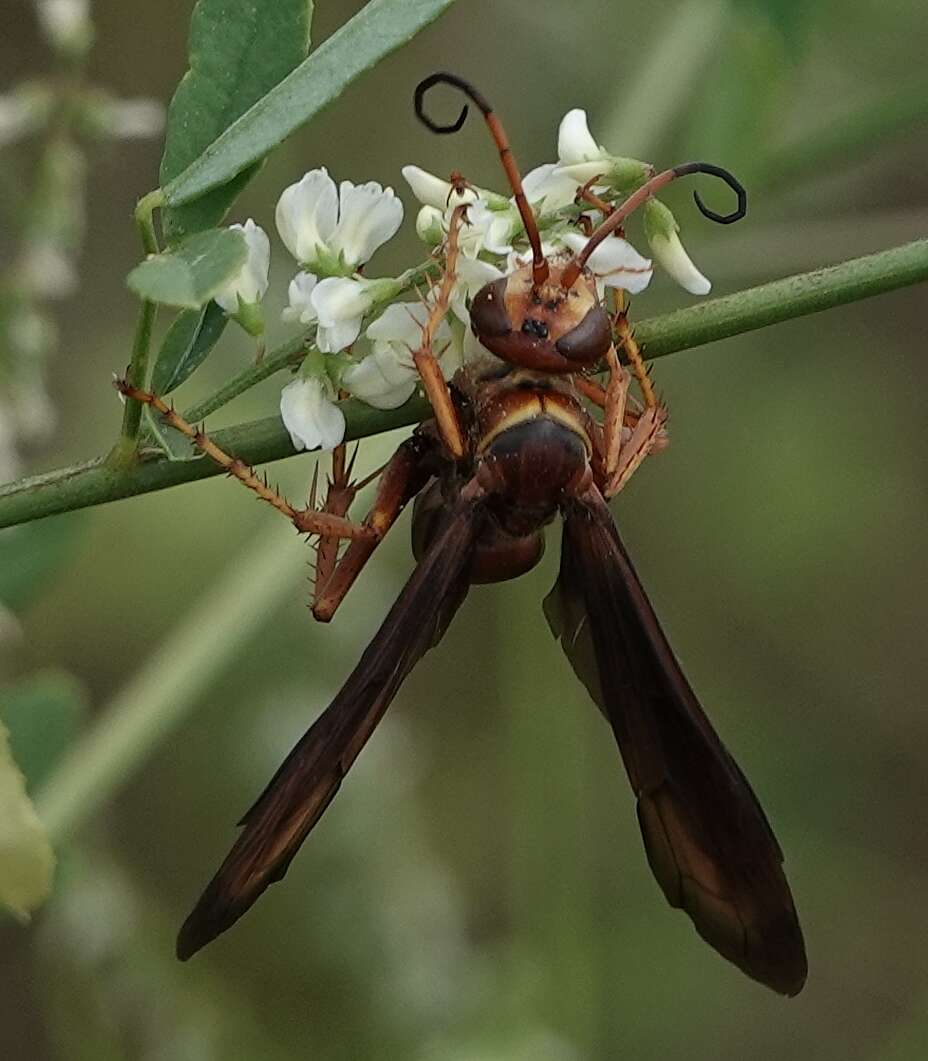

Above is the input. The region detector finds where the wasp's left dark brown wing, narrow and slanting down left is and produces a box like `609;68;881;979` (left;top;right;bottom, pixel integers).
177;491;483;960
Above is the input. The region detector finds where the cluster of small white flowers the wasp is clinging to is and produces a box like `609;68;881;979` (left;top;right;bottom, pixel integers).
215;109;710;449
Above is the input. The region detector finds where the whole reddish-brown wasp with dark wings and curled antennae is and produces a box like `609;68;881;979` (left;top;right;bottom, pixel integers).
123;72;806;995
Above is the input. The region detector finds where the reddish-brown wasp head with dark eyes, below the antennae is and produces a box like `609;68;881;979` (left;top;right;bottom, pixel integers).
471;265;612;372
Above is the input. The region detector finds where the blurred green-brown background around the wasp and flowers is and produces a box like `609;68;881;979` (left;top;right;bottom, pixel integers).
0;0;928;1061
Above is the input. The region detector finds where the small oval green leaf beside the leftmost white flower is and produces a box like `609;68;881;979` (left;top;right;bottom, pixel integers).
126;228;247;310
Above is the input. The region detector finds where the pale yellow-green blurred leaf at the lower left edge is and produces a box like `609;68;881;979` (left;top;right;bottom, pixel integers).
0;725;55;920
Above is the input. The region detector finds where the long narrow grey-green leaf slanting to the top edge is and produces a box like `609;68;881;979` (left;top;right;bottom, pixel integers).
163;0;454;206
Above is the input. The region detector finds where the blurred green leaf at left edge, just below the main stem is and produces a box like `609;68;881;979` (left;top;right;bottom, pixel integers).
0;516;81;611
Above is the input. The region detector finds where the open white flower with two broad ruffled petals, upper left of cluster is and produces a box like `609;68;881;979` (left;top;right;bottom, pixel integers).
275;168;403;276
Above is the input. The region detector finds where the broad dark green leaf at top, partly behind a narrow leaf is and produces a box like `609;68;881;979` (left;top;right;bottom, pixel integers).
160;0;313;243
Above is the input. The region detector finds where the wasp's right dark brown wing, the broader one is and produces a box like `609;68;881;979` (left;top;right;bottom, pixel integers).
545;487;806;995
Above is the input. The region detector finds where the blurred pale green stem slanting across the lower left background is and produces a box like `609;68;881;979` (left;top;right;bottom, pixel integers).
36;520;307;843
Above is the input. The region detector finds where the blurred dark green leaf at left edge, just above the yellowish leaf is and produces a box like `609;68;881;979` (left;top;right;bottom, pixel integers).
0;671;87;792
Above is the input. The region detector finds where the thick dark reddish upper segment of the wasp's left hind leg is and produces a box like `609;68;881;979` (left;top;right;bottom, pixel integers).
313;434;438;623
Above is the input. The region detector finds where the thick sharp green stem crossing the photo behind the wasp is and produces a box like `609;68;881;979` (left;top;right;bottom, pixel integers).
0;239;928;527
